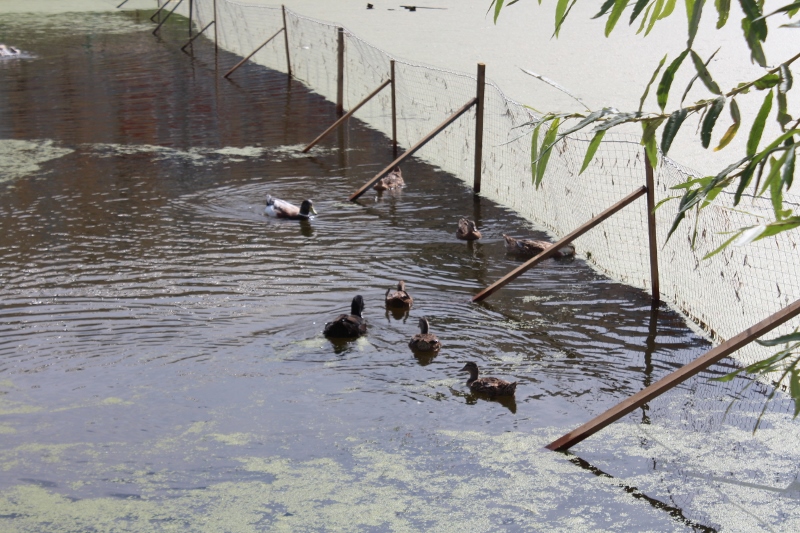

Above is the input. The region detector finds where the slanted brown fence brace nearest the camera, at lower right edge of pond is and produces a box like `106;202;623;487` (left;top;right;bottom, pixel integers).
546;300;800;451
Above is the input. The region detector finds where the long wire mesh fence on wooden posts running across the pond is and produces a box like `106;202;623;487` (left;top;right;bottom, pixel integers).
153;0;800;444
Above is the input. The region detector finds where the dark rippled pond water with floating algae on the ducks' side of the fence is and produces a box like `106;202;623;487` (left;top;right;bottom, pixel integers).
0;11;797;531
